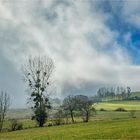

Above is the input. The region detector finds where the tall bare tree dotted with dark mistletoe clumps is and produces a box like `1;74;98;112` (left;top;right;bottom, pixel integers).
22;57;54;127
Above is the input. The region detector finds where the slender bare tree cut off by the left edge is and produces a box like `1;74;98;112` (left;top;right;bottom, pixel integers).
0;90;10;131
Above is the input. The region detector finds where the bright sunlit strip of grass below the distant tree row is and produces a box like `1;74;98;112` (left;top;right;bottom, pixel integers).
93;101;140;110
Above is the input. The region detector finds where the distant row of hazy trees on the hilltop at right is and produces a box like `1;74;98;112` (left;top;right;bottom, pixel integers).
97;86;131;100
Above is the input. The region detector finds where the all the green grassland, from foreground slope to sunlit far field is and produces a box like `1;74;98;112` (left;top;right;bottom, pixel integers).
0;101;140;140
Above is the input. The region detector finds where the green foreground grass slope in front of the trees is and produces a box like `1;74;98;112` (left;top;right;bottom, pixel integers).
0;118;140;140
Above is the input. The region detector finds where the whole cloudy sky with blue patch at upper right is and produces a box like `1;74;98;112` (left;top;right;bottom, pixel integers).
0;0;140;108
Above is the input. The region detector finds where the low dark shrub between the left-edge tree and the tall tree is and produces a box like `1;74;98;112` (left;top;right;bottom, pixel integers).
11;119;23;131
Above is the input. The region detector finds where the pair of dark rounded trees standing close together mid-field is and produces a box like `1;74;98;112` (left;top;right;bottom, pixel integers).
61;95;95;123
